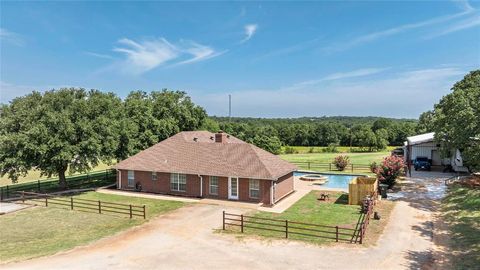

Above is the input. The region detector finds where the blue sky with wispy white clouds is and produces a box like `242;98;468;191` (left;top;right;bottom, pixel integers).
0;1;480;118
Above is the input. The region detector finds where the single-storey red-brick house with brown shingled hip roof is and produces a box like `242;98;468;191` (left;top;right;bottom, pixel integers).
115;131;297;205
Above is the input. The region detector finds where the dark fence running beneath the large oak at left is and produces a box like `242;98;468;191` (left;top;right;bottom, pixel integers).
0;169;117;200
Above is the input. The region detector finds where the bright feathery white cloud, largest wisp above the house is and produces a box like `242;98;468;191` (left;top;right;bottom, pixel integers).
113;38;225;75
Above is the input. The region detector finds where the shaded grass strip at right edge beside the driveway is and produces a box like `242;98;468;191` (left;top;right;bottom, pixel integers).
441;185;480;269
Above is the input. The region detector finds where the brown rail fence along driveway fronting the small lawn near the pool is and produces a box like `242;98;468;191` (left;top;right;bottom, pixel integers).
223;211;366;243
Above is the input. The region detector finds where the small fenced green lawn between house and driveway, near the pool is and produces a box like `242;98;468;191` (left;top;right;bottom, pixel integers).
227;191;360;244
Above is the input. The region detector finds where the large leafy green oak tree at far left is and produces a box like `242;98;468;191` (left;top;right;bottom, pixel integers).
0;88;121;188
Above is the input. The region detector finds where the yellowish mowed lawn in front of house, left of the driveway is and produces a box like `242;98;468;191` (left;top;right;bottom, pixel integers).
0;192;186;263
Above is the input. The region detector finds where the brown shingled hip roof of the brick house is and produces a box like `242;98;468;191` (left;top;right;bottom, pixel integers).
115;131;297;180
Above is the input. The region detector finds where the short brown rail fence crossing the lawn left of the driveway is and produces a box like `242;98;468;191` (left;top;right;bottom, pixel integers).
16;191;146;219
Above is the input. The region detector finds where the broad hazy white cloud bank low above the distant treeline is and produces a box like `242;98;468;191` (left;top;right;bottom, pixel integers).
192;67;465;118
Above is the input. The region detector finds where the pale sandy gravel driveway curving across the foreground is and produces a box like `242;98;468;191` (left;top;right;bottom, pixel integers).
0;188;442;270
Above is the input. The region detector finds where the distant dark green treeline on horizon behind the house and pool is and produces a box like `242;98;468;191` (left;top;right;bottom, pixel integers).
201;116;418;153
